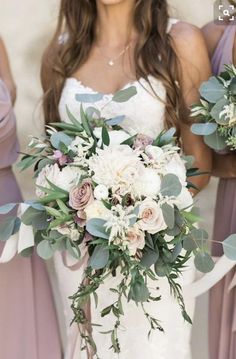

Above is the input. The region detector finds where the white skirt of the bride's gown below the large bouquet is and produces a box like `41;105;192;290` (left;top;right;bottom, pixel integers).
54;253;195;359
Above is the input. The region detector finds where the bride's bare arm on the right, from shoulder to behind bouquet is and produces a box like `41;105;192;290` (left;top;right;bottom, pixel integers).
171;22;212;194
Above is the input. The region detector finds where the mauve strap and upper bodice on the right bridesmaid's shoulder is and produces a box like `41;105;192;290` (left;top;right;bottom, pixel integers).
212;25;236;75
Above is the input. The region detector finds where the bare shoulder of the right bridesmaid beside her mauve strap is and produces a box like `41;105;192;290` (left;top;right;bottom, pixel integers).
202;21;226;56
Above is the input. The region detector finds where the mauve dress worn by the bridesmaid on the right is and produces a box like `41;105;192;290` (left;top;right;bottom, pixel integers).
209;25;236;359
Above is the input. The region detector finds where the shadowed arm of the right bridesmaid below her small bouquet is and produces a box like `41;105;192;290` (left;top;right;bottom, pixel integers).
212;153;236;178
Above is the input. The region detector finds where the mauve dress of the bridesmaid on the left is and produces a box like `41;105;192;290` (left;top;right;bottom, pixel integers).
0;79;62;359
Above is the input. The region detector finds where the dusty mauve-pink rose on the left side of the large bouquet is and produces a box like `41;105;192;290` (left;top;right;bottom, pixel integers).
69;180;94;211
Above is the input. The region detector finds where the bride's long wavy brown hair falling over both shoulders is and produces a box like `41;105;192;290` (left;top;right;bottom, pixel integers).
41;0;185;133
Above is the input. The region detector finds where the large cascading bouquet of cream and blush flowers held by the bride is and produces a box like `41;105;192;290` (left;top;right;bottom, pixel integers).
0;88;217;353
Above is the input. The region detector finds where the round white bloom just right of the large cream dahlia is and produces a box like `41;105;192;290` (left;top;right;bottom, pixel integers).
134;168;161;198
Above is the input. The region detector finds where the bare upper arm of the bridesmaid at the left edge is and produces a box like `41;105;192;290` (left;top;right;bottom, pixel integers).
0;38;16;104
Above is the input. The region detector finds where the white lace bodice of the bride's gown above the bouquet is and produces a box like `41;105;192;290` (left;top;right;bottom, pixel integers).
59;19;177;138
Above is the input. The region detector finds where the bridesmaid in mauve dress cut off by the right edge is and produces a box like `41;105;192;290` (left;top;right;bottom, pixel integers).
203;8;236;359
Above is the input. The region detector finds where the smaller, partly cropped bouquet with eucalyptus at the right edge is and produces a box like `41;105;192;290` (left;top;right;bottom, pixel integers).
192;65;236;151
